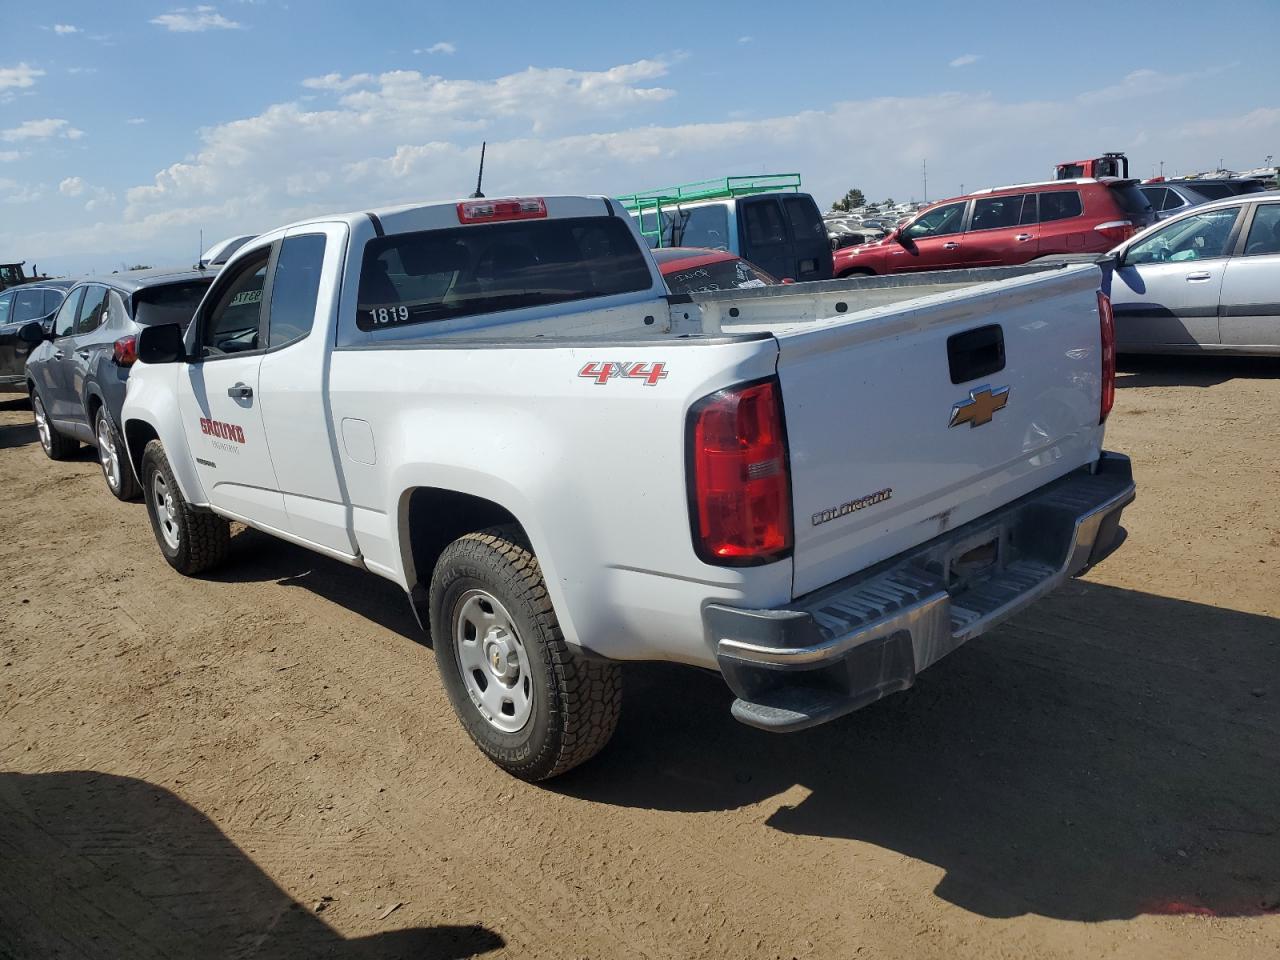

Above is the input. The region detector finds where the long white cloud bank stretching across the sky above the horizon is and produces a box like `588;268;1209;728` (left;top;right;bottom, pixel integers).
0;60;1280;268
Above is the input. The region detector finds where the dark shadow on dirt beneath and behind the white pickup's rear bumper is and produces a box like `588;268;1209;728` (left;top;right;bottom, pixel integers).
550;581;1280;920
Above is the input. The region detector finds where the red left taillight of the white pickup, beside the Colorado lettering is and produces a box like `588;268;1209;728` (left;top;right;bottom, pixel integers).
689;380;792;567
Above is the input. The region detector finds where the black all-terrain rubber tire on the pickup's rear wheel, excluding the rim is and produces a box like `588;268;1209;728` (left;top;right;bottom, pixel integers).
430;525;622;781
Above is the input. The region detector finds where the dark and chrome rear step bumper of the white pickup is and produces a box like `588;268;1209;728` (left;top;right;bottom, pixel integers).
703;453;1134;731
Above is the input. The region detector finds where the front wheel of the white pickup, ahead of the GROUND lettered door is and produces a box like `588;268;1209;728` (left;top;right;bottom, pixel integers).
142;440;232;576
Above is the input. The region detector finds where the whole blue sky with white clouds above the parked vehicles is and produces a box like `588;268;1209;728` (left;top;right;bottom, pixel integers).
0;0;1280;271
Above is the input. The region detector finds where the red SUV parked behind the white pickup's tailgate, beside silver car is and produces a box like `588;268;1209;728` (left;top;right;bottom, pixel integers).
835;177;1156;276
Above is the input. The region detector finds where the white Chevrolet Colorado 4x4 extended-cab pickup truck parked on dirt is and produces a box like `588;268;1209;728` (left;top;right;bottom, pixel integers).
123;197;1134;780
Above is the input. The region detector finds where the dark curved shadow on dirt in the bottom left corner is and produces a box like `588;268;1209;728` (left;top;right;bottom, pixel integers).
0;771;506;960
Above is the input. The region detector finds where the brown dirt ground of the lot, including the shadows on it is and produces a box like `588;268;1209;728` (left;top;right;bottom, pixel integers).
0;361;1280;960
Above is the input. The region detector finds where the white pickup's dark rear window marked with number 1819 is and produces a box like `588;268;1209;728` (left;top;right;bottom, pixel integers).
356;216;653;330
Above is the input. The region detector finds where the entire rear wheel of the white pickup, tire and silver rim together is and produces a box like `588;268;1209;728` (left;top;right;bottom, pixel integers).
430;526;622;781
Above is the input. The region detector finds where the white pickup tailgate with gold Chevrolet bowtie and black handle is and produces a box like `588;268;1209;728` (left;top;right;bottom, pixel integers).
774;259;1102;596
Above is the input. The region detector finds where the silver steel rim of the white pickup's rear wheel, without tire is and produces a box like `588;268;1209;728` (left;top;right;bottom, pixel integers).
453;590;534;733
